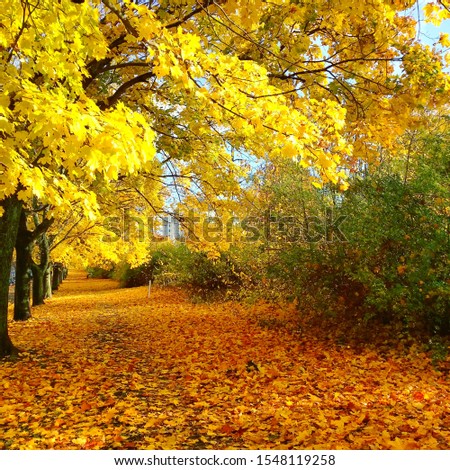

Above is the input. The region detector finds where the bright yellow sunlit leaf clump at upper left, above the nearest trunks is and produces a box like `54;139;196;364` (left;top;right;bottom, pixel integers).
0;2;156;217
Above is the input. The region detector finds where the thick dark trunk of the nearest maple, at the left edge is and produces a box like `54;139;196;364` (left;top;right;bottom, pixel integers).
0;196;22;357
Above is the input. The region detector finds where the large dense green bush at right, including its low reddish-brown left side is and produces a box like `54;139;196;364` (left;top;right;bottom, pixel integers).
268;146;450;335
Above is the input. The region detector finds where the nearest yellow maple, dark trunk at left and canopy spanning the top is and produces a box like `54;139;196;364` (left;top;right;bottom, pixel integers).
0;0;449;354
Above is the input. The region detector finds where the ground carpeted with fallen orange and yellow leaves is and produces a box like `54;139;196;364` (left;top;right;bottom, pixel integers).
0;274;450;449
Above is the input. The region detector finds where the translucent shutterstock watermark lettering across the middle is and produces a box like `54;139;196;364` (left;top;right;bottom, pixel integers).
103;208;347;243
